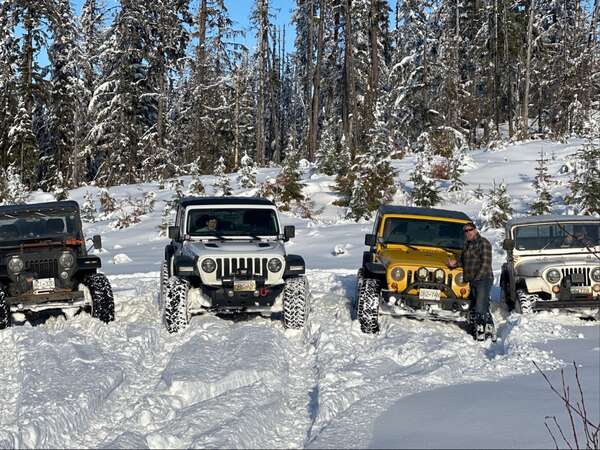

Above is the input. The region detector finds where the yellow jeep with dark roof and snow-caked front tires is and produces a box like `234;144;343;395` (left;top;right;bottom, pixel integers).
353;205;471;333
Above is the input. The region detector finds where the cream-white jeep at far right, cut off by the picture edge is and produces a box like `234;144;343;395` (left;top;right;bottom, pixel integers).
500;215;600;313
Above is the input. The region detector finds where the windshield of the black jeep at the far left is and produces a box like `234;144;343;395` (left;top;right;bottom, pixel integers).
0;210;80;246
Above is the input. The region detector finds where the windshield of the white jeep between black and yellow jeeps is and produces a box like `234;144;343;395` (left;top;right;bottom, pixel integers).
186;208;279;238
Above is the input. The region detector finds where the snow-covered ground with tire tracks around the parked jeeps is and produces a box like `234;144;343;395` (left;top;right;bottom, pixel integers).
0;140;600;448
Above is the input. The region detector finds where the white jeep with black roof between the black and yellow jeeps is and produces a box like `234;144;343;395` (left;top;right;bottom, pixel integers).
161;197;309;333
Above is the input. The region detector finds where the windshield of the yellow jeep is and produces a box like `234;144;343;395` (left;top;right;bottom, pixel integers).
383;217;465;249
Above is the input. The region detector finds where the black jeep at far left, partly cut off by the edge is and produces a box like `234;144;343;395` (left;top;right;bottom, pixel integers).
0;201;115;329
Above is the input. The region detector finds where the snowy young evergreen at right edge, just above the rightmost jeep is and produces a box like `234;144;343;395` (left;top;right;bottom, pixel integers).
566;140;600;215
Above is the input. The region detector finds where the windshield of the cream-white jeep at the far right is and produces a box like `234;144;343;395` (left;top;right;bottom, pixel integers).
514;222;600;251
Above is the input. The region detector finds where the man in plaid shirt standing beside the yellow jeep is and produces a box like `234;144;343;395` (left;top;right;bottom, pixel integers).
448;222;494;340
